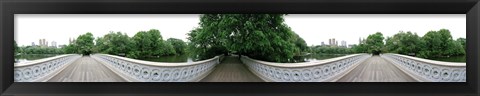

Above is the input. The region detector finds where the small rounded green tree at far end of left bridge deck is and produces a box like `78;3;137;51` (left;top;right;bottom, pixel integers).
75;32;95;55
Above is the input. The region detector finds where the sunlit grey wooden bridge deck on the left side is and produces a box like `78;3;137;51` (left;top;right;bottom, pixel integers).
48;56;126;82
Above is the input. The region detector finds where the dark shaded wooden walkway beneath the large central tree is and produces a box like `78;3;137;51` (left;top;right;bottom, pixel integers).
200;56;264;82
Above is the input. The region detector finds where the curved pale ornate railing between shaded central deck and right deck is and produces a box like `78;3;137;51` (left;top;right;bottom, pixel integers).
241;54;371;82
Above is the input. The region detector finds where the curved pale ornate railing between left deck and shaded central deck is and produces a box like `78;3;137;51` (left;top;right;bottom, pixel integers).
92;54;223;82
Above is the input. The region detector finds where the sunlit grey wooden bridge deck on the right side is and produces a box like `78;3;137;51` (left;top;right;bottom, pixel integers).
337;56;416;82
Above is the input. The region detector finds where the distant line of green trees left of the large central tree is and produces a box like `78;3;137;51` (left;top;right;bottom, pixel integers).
14;29;187;58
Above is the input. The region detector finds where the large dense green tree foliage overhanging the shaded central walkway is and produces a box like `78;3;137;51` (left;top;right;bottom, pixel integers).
188;14;299;62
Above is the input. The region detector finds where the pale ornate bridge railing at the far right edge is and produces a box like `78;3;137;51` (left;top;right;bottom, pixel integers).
381;53;466;82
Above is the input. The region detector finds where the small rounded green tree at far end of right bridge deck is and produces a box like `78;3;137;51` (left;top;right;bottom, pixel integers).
365;32;384;55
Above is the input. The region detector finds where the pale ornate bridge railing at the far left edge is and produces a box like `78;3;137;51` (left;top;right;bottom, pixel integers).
13;54;81;82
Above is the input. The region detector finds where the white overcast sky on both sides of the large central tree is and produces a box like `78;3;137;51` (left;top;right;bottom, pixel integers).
15;14;466;46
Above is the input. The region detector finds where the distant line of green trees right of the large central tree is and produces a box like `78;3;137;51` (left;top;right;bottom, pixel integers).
310;29;466;58
